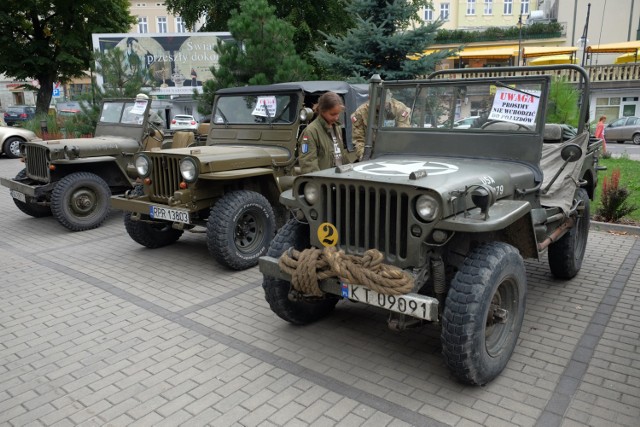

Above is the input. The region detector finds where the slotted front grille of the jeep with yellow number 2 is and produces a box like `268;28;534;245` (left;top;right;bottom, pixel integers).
322;184;410;263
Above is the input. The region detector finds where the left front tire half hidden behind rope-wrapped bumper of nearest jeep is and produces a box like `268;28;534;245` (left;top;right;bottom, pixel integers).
262;219;339;325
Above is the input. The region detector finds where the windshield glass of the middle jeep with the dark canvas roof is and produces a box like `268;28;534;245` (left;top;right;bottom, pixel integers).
213;94;298;125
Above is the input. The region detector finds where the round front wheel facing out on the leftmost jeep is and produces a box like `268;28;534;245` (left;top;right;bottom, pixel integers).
51;172;111;231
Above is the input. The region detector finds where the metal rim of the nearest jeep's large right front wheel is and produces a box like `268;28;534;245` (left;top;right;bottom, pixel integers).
485;277;519;357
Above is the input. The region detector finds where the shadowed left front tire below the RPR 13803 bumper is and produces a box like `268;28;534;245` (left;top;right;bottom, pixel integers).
124;185;183;249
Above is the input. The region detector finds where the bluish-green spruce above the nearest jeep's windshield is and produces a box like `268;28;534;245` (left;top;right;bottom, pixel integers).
313;0;449;79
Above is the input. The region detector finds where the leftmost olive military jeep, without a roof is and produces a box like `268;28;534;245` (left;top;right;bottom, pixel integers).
0;99;178;231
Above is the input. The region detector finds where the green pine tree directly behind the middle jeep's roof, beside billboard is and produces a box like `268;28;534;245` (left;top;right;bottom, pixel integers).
197;0;313;114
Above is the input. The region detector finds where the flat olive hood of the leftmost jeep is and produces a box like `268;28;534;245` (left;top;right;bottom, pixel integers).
28;136;140;158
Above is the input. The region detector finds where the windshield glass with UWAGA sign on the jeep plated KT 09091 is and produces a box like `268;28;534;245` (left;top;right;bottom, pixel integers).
381;79;544;133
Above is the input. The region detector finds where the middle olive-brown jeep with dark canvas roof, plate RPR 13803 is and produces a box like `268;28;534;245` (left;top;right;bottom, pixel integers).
111;81;368;270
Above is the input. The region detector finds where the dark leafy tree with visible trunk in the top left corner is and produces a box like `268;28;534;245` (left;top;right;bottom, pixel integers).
0;0;135;113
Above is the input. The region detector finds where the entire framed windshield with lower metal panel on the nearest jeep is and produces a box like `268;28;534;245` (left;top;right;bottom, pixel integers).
367;75;551;164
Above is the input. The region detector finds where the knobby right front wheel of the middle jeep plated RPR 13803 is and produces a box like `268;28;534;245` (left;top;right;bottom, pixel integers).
207;190;276;270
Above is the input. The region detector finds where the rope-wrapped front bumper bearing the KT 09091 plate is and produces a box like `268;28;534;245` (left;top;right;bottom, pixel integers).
258;256;438;322
